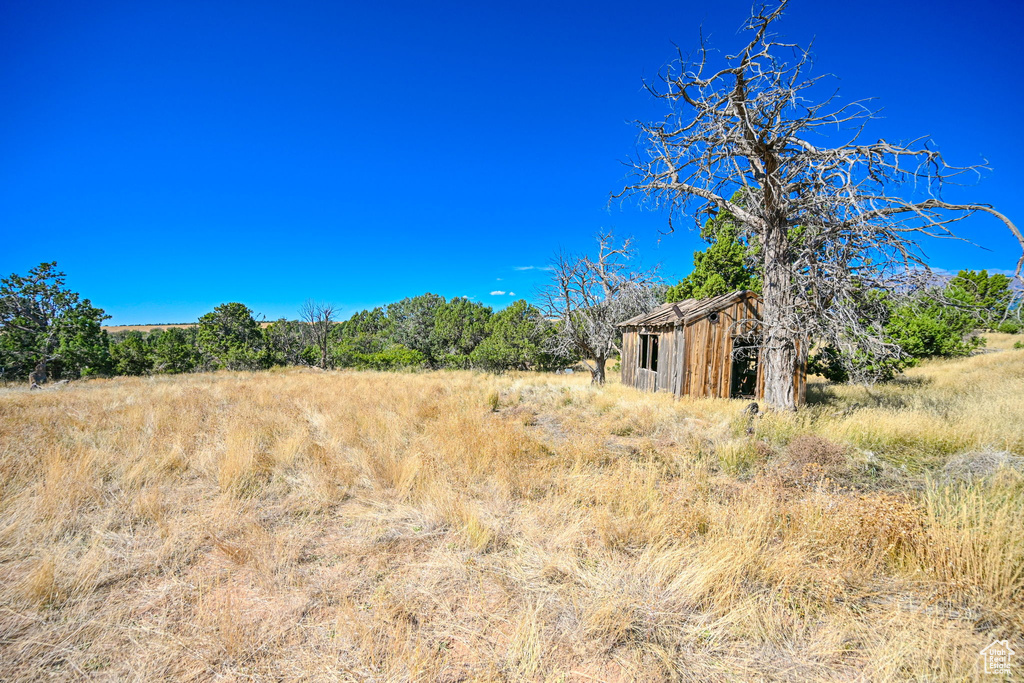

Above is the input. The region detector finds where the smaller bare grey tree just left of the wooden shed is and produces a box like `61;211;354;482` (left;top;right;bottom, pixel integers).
539;233;659;384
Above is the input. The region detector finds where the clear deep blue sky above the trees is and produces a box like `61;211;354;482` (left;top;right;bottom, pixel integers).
0;0;1024;324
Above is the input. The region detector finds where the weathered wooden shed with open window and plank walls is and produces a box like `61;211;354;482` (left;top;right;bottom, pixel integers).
618;290;807;403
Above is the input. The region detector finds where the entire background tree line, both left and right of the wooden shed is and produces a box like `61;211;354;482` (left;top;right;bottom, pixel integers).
0;245;1024;384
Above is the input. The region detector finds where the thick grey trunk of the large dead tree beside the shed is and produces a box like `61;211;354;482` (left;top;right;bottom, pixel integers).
761;225;797;411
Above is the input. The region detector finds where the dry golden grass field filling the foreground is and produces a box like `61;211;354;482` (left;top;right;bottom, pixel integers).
0;338;1024;682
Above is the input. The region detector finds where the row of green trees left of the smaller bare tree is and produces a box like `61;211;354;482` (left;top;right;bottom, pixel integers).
0;262;578;381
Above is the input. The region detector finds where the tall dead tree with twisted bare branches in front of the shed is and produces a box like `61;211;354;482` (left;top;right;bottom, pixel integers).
614;0;1024;410
